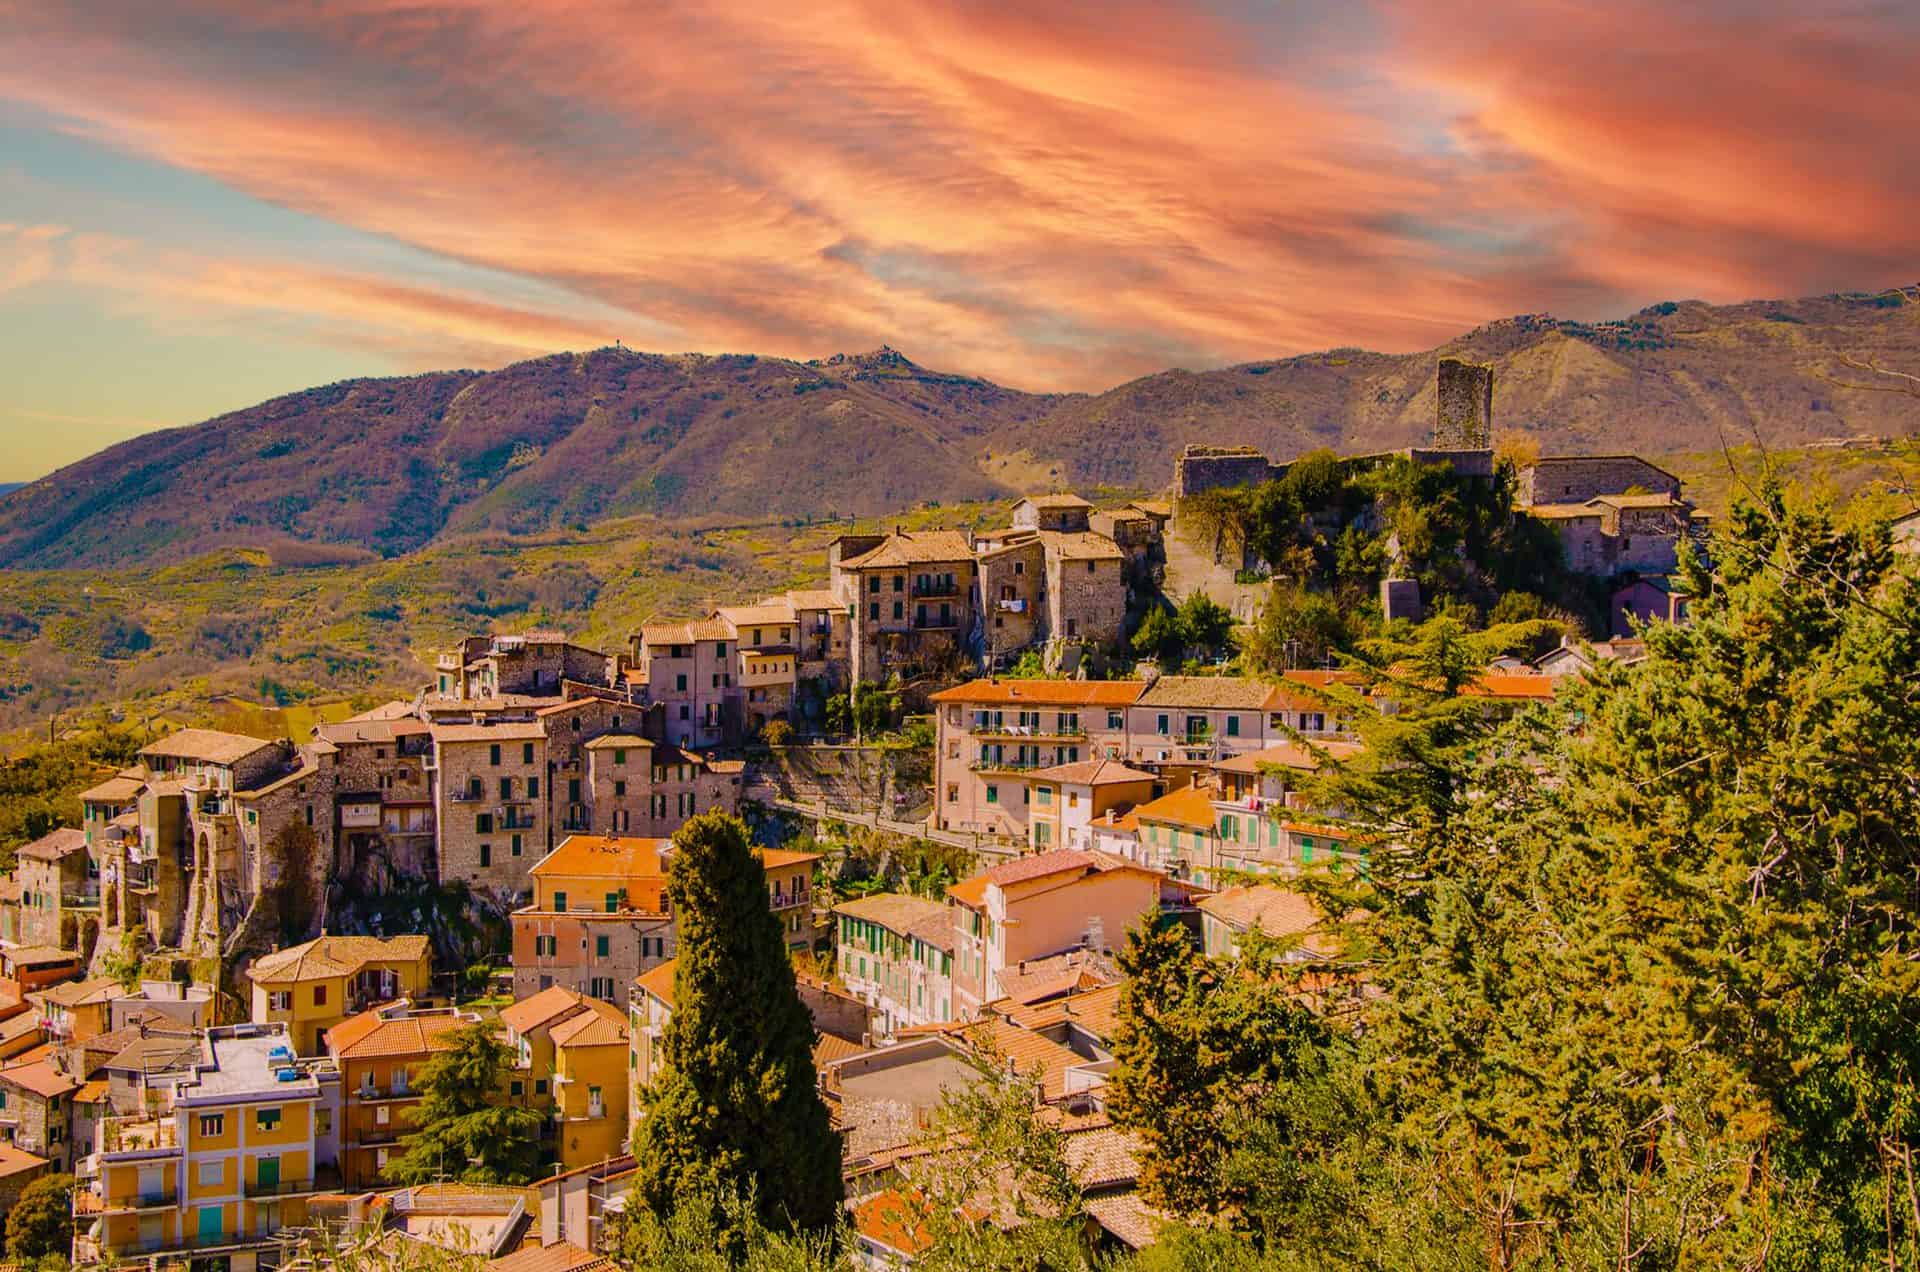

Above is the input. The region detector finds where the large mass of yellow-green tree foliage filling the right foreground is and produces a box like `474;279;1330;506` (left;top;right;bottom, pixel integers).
1116;490;1920;1270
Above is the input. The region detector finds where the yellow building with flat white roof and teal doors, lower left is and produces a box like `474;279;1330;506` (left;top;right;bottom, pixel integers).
73;1024;338;1272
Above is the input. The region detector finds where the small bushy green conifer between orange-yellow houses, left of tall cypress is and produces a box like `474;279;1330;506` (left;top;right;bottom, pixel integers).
386;1022;540;1184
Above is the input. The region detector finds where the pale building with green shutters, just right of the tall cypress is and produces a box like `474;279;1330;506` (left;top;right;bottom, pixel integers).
833;892;954;1034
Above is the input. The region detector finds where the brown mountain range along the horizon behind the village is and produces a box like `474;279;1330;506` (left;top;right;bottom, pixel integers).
0;288;1920;569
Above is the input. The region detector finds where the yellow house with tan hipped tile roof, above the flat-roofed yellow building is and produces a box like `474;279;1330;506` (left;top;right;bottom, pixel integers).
248;936;434;1055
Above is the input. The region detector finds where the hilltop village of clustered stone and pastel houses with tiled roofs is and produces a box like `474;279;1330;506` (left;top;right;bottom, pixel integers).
0;361;1781;1272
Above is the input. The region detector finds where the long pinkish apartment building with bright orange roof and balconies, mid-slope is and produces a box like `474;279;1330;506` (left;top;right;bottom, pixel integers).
929;680;1146;840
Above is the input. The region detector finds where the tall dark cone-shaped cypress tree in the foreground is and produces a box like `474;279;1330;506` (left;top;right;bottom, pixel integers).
634;813;841;1235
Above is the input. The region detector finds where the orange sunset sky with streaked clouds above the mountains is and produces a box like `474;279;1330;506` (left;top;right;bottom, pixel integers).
0;0;1920;480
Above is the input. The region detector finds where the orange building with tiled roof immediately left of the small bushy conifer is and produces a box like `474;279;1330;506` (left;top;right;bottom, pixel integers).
326;999;480;1189
